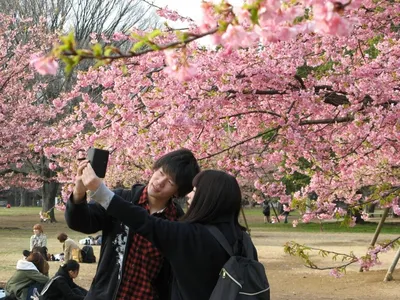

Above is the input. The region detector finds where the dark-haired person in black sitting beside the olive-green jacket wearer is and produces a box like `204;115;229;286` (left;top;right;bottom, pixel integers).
40;259;87;300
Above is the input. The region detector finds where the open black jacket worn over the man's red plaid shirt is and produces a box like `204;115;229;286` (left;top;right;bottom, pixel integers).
65;184;183;300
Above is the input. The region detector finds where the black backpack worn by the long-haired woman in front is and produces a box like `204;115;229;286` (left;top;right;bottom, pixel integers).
206;225;270;300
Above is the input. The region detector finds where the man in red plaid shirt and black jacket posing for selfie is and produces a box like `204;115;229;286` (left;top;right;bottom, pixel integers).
65;149;200;300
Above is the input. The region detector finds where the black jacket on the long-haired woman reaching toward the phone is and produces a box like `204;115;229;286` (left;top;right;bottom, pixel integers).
107;195;257;300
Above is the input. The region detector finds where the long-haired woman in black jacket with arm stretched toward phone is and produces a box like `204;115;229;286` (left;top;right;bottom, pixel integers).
78;162;257;300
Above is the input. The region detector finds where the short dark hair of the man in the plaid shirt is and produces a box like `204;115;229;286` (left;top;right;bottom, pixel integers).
153;149;200;197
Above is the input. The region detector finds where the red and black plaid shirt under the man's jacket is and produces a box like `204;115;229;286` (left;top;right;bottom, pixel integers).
117;187;177;300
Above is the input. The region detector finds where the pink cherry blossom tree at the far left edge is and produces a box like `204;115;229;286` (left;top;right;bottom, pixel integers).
0;15;57;210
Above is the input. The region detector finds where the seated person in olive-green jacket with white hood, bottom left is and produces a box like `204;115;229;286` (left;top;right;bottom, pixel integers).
5;252;49;300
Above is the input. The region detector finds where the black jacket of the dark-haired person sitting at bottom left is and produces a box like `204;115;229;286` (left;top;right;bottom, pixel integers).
41;269;85;300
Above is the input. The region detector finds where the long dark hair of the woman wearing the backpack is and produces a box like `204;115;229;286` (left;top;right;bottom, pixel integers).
181;170;244;230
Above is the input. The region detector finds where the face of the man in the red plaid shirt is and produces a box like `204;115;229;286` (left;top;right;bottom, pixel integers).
147;168;178;200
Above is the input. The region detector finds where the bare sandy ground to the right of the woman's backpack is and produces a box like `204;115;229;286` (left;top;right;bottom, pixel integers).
252;231;400;300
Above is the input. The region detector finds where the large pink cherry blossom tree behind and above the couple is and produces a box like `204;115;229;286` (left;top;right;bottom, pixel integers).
30;0;400;271
